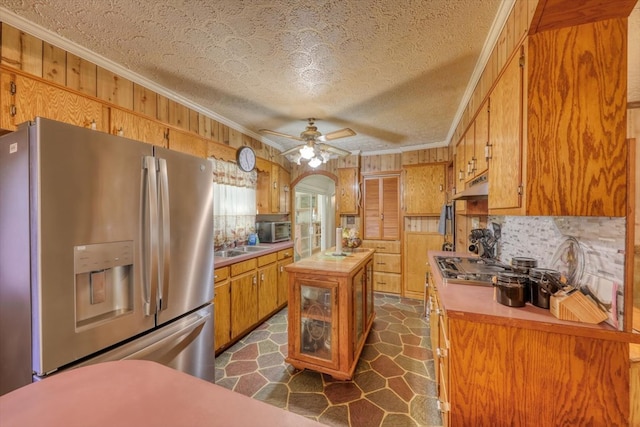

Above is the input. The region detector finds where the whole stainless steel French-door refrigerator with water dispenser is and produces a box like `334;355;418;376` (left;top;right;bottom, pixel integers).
0;118;215;394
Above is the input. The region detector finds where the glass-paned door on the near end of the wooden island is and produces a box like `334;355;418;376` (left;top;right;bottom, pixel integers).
298;281;338;363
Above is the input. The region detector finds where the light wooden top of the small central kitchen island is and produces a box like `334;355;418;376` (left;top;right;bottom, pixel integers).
285;248;375;276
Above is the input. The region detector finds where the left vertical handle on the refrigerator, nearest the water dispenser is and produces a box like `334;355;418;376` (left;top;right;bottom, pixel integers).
143;156;158;316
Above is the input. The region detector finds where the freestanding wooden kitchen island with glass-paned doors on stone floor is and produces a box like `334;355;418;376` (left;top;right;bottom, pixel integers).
285;248;375;380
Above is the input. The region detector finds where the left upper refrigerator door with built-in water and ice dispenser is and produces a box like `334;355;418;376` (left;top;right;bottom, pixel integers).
32;118;155;374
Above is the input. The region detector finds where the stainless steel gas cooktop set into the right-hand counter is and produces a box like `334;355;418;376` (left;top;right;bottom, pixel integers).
434;256;511;286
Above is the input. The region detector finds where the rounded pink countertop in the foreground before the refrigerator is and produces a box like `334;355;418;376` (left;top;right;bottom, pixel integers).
0;360;321;427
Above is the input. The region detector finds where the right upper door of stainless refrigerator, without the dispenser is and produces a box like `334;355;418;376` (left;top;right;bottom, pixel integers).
155;147;213;324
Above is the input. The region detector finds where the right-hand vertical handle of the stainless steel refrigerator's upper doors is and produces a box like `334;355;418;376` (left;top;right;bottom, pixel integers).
158;158;171;311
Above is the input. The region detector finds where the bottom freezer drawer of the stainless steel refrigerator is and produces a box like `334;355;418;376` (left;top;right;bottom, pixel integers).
67;304;215;382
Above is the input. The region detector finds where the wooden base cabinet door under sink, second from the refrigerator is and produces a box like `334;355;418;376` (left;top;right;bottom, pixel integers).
231;271;258;339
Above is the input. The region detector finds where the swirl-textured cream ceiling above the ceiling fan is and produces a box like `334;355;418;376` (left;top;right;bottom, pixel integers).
0;0;640;153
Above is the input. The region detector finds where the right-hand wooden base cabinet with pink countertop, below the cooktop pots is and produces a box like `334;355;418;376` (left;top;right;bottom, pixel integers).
426;251;640;426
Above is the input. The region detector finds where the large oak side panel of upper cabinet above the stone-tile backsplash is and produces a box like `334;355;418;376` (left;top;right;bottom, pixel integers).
524;19;627;216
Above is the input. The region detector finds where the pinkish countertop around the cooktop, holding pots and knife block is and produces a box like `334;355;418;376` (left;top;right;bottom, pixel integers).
429;251;640;343
